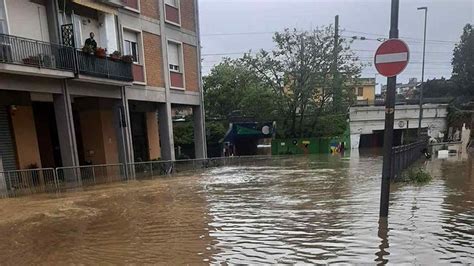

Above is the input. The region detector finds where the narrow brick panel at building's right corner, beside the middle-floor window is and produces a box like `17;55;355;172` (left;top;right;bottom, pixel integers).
181;44;199;91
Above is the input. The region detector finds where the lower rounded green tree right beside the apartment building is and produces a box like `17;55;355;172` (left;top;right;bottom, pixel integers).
204;59;274;121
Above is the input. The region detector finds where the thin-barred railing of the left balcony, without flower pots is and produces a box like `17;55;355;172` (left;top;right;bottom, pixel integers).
0;34;75;71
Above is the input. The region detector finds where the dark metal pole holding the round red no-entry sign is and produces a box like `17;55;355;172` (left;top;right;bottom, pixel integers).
380;0;399;217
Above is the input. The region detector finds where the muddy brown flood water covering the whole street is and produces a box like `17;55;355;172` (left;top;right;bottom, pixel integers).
0;154;474;265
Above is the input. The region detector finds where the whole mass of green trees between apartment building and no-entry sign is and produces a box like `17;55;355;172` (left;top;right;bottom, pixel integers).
204;26;362;138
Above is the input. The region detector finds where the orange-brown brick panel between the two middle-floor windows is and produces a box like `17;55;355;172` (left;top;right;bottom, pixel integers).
143;31;165;87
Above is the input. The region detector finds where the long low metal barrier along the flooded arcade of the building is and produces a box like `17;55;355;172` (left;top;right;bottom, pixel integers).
0;156;275;198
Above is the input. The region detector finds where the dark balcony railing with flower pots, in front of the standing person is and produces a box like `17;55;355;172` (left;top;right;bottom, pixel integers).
76;50;133;81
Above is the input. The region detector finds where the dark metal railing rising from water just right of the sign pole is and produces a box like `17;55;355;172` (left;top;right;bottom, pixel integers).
390;139;428;179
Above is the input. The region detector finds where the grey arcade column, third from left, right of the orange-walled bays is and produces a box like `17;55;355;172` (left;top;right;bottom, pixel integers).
158;102;175;161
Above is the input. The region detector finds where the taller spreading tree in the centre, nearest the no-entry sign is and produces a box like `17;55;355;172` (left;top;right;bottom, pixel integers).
243;26;361;137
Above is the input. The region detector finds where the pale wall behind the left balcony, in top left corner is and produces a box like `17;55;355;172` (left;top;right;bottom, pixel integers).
6;0;49;42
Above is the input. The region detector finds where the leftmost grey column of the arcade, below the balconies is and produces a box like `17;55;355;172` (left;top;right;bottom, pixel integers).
53;81;79;166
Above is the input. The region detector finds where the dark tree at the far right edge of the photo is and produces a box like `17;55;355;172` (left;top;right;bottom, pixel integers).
452;24;474;97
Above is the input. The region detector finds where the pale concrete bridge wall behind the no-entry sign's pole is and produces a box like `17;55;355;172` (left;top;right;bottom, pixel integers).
349;103;448;149
